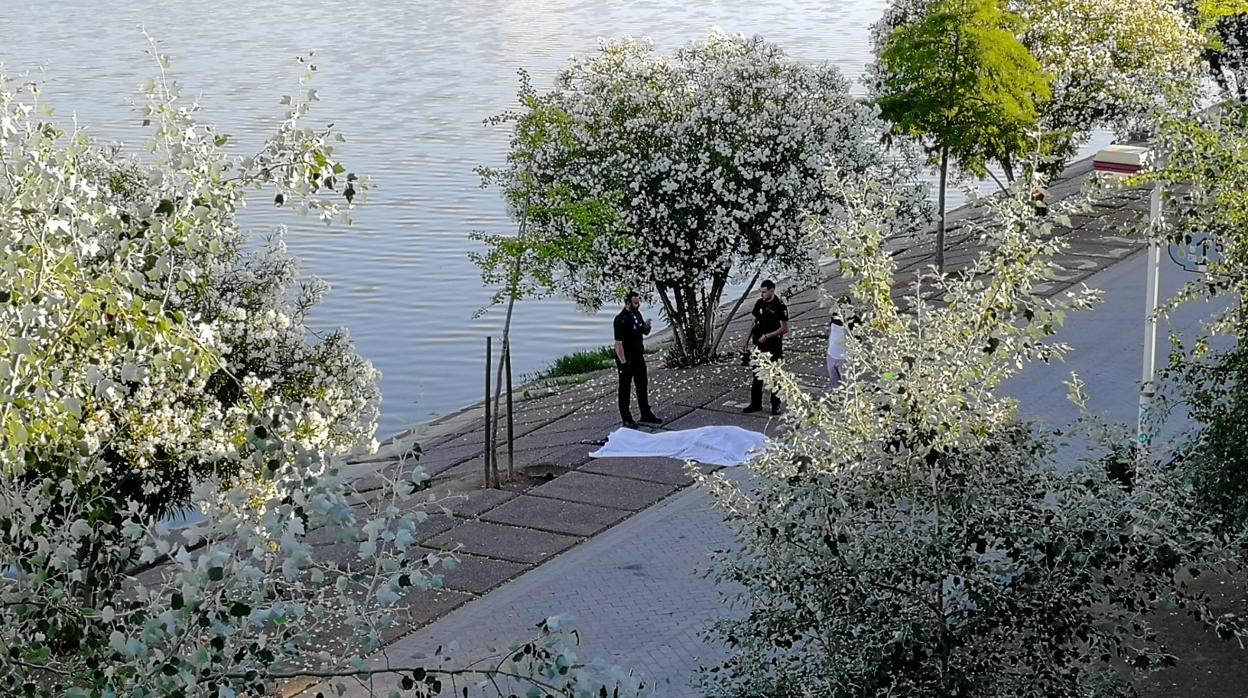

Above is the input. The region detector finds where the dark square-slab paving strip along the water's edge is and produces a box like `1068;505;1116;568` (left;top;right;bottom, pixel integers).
324;154;1147;628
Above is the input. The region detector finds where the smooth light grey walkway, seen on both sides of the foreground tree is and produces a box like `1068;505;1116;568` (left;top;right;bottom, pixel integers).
314;243;1229;698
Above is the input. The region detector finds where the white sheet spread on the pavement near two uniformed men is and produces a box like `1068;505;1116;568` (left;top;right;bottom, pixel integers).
590;426;768;466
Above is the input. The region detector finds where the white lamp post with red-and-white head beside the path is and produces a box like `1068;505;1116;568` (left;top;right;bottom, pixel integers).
1092;145;1162;460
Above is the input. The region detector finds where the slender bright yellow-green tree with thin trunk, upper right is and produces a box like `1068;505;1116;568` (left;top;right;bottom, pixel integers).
875;0;1050;271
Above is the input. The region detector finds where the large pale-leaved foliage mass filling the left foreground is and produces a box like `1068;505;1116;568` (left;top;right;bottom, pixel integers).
0;56;636;697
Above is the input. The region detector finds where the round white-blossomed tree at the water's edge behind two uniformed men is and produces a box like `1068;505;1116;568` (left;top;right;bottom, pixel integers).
475;34;926;363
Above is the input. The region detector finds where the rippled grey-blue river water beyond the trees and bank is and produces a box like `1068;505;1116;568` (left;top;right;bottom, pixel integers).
0;0;983;435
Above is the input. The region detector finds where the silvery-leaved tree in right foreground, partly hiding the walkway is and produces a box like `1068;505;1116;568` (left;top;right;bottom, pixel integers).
704;171;1236;698
